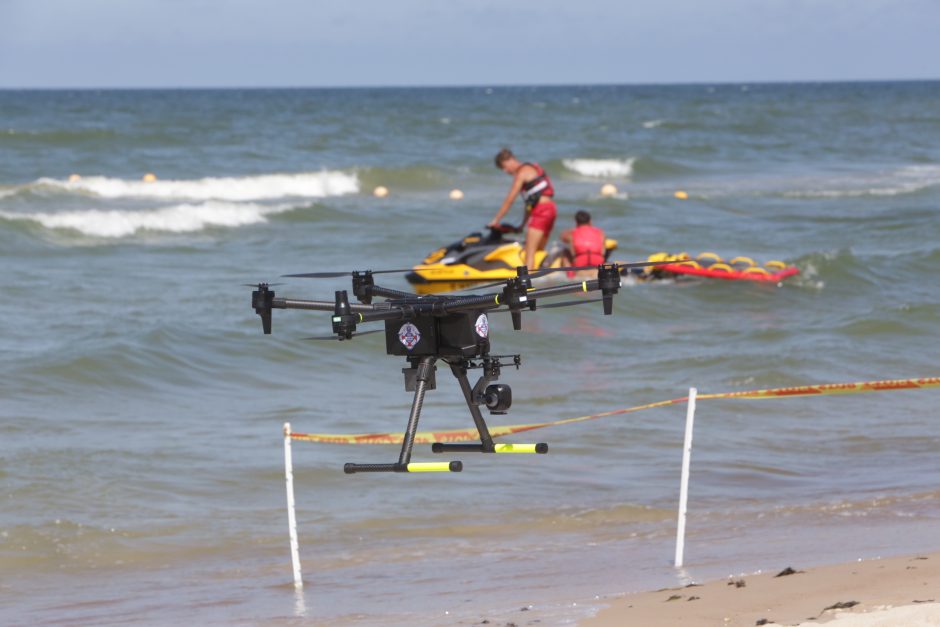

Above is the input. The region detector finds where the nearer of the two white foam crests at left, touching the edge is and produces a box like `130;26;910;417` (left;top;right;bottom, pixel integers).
0;200;293;238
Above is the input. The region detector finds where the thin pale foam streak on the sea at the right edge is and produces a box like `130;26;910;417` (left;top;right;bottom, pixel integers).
784;165;940;198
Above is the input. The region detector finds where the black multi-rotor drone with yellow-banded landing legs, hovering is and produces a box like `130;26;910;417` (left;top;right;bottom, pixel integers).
250;262;657;474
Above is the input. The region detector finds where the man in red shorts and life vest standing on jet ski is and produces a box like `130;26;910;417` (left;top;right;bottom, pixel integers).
487;148;558;270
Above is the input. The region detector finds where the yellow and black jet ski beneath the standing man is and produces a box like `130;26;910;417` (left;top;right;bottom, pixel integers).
405;224;617;292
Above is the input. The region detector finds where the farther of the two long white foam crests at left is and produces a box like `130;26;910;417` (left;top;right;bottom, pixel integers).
34;170;359;201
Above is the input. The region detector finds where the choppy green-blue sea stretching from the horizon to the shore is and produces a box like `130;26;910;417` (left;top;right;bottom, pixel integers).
0;81;940;625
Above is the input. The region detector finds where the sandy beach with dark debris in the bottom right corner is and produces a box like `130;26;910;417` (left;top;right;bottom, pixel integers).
581;552;940;627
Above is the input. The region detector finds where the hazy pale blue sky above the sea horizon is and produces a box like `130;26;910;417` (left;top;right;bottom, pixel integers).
0;0;940;88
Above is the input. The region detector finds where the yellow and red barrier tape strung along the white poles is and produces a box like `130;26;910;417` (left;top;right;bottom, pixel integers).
291;377;940;444
